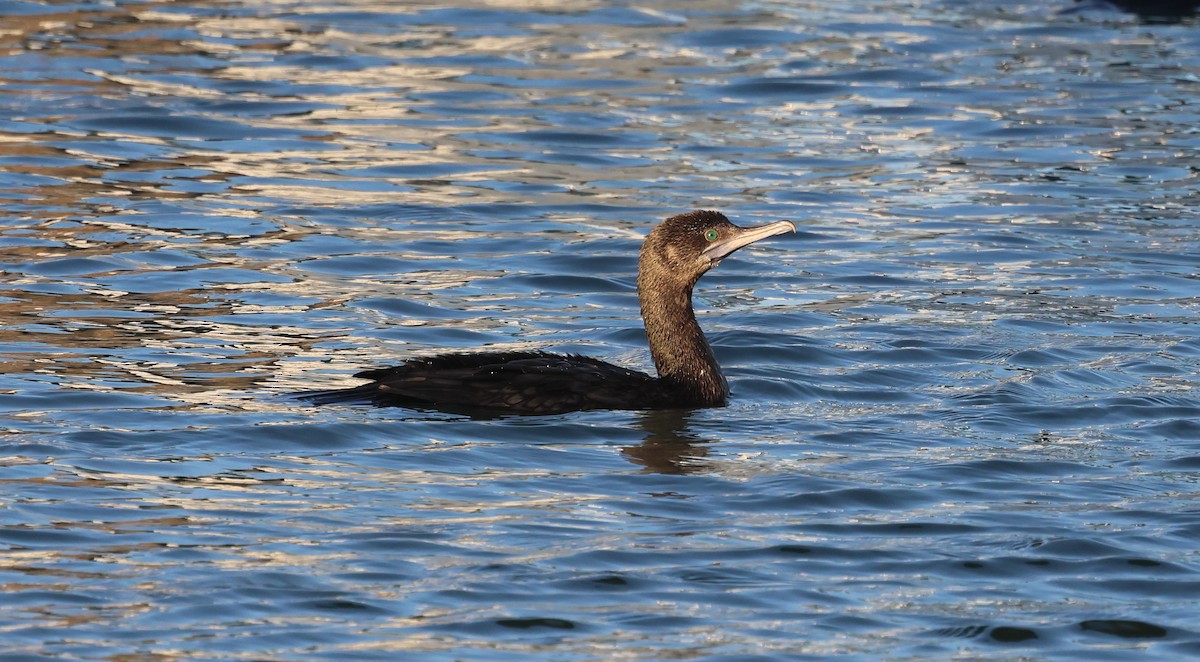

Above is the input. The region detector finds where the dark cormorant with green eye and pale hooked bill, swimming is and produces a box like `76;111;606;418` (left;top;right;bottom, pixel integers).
300;211;796;414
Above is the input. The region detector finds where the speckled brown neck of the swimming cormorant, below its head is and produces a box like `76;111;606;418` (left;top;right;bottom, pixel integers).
637;278;730;405
